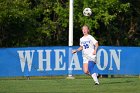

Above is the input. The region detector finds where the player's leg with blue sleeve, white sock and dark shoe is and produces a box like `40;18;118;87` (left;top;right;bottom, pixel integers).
88;61;99;85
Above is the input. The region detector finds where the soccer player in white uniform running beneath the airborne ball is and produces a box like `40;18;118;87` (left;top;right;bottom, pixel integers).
72;25;99;85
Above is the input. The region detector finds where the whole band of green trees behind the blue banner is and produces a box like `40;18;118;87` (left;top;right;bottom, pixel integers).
0;0;140;47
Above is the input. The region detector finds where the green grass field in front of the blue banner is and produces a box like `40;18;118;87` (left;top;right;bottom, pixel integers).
0;77;140;93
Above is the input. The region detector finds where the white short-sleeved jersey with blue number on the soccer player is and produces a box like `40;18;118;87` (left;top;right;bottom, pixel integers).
80;35;98;62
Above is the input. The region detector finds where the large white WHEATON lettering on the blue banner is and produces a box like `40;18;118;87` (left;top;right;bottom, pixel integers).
17;49;122;73
